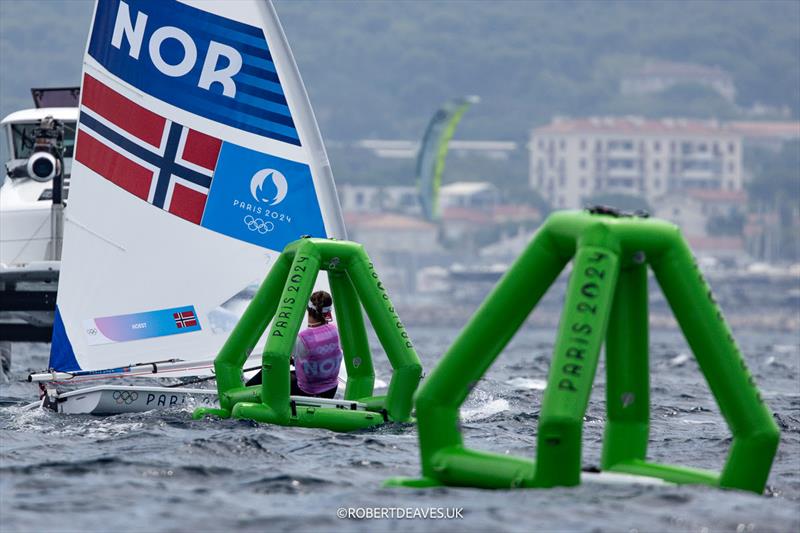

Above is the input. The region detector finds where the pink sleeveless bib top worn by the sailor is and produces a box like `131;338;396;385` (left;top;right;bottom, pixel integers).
294;323;342;394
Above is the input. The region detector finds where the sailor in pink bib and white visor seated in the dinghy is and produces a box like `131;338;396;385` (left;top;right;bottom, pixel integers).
247;291;342;398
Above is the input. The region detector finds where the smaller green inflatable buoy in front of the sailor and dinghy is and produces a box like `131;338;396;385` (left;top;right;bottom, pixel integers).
193;238;422;431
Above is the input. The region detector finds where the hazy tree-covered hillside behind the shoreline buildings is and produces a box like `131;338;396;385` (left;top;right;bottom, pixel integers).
276;0;800;140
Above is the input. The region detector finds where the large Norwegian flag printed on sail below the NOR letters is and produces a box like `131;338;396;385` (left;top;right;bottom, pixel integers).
75;75;222;222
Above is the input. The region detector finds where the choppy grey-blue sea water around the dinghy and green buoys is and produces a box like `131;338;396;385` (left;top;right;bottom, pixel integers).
0;327;800;531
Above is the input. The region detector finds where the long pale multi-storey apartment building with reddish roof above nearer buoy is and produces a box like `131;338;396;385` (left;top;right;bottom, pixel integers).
528;117;742;208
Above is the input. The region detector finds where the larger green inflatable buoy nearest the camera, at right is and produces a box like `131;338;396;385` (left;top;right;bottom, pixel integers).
387;208;779;493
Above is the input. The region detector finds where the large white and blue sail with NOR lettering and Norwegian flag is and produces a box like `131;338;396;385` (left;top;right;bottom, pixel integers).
50;0;346;371
